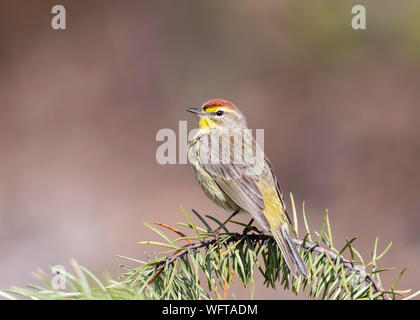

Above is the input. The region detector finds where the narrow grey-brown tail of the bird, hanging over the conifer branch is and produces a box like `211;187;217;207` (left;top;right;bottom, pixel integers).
271;226;307;278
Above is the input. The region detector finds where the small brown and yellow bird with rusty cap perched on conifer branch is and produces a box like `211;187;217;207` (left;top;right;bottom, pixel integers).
185;99;307;277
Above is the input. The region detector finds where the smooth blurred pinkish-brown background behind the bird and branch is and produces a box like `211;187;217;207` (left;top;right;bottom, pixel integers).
0;0;420;299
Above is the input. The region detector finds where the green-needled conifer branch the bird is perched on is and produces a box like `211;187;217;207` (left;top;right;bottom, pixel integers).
0;197;414;300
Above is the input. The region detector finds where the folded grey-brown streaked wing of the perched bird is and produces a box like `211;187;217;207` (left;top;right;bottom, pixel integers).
199;130;269;229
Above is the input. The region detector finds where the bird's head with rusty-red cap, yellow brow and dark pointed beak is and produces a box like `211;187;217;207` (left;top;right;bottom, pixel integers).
185;99;246;130
